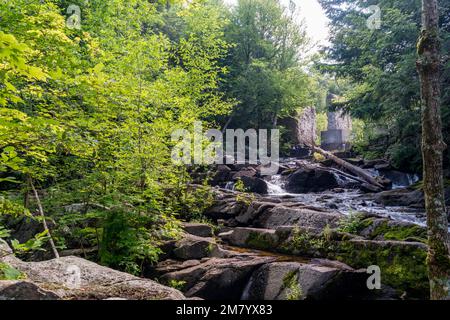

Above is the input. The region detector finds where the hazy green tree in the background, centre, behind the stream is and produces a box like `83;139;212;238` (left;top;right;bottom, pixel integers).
222;0;315;128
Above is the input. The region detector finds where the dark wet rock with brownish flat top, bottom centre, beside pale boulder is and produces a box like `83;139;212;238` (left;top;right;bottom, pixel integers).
162;256;274;300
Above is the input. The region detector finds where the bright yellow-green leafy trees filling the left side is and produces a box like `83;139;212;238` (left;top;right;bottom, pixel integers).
0;0;237;274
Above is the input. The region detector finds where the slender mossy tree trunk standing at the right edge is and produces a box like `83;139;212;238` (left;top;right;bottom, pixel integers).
417;0;450;300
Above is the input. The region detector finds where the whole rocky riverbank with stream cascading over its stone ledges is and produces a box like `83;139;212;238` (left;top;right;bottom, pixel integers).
0;161;450;300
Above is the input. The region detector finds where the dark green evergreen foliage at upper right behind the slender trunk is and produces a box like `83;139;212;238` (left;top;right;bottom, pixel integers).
319;0;450;172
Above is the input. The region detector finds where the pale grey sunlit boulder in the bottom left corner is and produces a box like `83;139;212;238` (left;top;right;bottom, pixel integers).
0;240;185;300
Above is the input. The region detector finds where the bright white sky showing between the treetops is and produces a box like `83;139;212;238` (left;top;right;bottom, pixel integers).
224;0;329;49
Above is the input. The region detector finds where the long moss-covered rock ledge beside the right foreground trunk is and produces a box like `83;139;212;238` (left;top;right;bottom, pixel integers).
277;228;429;298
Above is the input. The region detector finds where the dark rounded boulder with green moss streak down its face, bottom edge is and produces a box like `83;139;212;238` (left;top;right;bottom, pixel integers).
242;262;368;300
